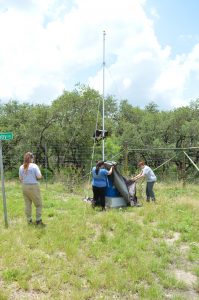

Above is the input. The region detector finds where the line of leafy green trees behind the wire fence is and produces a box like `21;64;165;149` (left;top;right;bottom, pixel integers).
0;85;199;183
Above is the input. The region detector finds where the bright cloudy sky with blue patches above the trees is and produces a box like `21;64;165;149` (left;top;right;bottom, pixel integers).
0;0;199;109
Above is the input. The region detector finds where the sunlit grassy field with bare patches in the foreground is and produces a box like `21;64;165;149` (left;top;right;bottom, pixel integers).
0;182;199;300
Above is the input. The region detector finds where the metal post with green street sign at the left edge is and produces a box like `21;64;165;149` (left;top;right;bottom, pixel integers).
0;132;13;227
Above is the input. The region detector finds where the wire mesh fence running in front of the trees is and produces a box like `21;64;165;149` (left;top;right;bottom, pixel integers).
3;143;199;191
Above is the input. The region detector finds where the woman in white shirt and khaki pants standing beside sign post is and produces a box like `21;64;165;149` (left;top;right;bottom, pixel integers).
19;152;45;226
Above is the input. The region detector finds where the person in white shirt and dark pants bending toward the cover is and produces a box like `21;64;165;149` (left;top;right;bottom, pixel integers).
131;161;157;202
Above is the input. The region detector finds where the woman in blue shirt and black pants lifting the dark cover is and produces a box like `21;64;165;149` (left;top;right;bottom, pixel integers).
92;161;113;210
